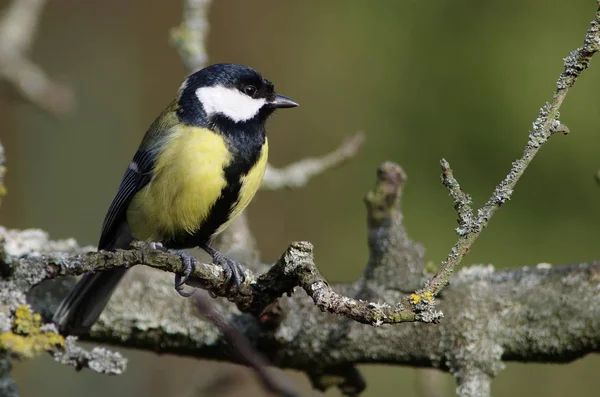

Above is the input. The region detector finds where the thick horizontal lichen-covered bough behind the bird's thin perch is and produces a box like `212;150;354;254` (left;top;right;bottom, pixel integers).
22;241;600;376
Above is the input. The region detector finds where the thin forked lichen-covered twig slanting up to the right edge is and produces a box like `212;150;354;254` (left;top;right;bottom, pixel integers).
425;2;600;295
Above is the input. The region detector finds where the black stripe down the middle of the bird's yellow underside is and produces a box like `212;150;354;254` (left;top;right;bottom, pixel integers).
163;114;265;249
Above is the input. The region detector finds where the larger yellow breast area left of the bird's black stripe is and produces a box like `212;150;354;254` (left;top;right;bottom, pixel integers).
127;127;231;241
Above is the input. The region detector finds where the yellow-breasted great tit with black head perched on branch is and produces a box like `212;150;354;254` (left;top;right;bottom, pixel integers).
53;63;298;334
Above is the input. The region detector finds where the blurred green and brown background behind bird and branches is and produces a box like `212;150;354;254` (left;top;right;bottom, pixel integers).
0;0;600;397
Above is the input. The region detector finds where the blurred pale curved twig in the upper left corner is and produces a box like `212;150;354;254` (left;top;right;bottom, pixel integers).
0;0;73;114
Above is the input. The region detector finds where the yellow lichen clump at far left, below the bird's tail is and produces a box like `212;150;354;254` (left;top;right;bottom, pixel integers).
0;305;65;358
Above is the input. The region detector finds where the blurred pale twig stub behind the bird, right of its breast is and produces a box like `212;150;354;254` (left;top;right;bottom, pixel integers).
261;132;365;190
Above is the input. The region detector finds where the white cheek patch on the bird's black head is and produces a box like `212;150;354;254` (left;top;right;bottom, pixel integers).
196;85;267;123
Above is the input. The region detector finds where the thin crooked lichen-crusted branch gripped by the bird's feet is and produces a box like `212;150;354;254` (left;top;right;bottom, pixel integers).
0;224;429;325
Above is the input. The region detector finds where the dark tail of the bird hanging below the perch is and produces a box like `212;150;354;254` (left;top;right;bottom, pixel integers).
53;268;127;334
